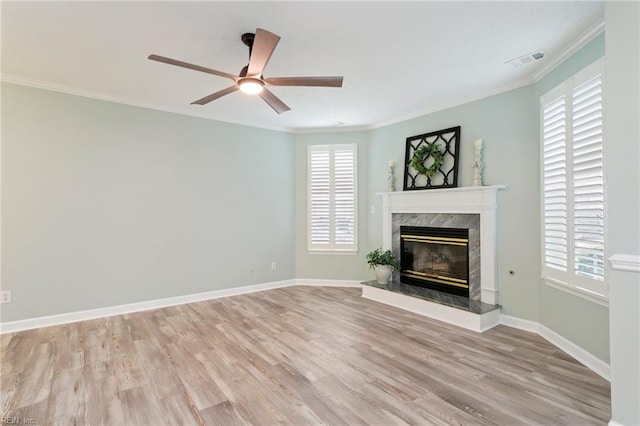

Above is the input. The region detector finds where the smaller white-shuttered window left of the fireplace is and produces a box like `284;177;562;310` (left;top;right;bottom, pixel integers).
307;144;358;252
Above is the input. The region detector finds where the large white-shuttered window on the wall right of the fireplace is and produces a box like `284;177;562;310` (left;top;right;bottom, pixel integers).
541;61;607;299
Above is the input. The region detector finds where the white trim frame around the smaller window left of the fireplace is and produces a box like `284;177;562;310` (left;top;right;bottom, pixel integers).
306;143;358;255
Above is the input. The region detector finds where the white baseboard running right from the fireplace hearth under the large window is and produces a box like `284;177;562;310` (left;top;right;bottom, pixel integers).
500;314;611;381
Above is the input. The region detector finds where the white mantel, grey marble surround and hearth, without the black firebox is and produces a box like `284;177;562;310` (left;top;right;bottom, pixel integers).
363;185;504;331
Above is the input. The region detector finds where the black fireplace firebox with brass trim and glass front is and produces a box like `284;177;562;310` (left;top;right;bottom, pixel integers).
400;226;469;297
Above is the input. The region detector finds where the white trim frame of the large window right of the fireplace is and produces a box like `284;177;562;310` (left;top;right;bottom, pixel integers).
539;58;609;306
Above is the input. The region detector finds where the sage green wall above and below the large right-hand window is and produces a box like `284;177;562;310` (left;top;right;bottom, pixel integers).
535;34;611;362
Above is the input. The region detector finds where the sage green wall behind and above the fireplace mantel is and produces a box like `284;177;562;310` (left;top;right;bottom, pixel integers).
368;86;540;321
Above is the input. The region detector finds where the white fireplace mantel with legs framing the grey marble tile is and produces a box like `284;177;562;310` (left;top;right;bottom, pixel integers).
378;185;505;305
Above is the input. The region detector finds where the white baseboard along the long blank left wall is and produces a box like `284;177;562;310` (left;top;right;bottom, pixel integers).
0;279;296;334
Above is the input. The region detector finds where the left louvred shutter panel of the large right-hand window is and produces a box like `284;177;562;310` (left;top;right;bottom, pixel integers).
542;96;568;271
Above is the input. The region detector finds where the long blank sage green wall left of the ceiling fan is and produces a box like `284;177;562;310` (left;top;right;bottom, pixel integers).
1;84;295;322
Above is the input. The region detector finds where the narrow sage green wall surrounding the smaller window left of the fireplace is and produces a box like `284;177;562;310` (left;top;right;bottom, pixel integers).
296;132;368;281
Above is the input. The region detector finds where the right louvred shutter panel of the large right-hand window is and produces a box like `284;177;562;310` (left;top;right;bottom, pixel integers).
572;75;604;280
